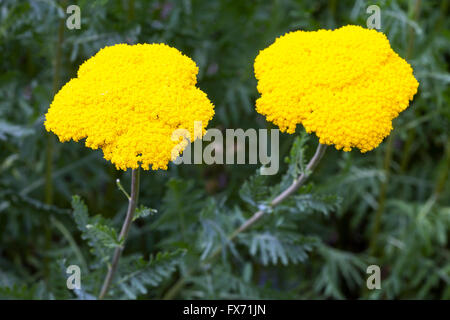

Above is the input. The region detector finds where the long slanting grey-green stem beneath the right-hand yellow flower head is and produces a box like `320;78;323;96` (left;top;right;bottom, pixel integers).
163;143;327;300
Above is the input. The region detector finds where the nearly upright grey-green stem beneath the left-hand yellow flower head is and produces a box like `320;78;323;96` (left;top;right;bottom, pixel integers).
98;168;139;299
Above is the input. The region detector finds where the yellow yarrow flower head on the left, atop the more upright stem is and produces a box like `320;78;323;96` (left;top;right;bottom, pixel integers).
45;44;214;170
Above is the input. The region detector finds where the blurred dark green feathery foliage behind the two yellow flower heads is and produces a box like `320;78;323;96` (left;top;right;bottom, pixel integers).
0;0;450;299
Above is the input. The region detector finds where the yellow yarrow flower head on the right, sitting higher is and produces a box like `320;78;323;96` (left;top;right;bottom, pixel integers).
254;25;419;152
